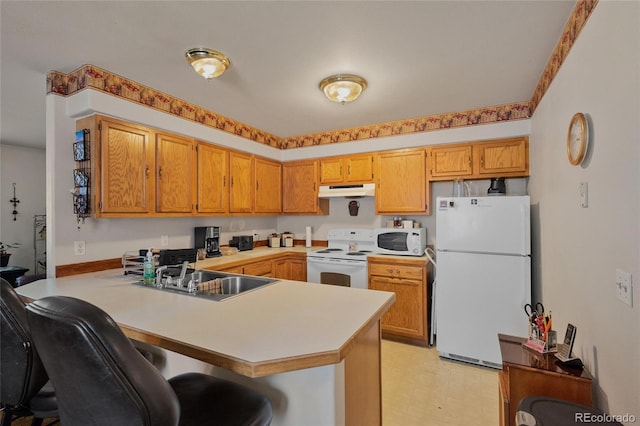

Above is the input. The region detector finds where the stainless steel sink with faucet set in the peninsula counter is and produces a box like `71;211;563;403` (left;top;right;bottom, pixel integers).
134;270;278;301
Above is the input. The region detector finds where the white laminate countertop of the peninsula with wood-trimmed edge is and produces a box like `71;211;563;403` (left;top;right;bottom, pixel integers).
16;268;395;377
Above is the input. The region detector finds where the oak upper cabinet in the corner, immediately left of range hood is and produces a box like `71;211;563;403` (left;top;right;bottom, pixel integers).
282;160;329;214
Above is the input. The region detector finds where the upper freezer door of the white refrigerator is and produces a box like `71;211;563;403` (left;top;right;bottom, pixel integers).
436;196;531;255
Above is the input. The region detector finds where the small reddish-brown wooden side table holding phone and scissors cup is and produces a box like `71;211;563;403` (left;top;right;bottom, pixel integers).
498;334;593;426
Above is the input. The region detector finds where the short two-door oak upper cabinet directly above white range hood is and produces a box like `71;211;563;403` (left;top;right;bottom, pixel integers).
320;154;375;185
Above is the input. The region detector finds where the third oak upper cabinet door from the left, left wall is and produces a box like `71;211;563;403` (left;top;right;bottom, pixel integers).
197;143;229;214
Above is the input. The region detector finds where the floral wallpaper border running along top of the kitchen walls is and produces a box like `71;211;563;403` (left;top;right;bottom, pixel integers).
47;0;598;149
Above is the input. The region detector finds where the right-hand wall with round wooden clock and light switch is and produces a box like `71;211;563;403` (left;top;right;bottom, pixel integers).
529;1;640;421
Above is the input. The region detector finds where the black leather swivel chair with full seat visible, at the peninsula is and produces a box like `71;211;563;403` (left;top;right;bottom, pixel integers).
27;296;272;426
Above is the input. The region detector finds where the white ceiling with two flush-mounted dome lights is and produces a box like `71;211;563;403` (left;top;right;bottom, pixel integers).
0;0;576;147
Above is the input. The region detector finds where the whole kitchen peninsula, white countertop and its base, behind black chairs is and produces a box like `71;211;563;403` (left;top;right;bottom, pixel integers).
17;270;395;425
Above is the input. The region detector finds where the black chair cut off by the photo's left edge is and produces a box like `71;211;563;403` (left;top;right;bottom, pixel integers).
0;278;58;426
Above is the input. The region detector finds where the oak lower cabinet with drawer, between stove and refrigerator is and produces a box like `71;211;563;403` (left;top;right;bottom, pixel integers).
369;256;428;345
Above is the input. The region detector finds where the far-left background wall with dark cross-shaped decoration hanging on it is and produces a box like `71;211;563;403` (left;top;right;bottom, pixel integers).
0;144;45;275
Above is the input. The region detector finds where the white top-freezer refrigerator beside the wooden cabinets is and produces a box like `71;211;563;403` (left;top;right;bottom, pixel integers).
434;196;531;368
